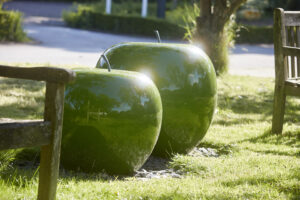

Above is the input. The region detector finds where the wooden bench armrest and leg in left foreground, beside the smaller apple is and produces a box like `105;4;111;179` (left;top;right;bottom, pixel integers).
0;65;75;200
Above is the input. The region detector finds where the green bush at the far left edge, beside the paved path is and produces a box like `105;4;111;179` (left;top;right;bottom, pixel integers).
0;9;27;42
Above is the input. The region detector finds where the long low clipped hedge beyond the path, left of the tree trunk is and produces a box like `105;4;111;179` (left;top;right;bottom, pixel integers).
63;9;185;39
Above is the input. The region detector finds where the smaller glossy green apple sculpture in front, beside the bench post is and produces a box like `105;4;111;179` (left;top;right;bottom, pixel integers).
61;69;162;174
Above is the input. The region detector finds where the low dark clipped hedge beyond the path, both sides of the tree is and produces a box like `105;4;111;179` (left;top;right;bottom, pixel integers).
64;9;273;44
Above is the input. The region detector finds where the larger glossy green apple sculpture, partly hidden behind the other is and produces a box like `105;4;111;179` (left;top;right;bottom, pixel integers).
96;43;217;156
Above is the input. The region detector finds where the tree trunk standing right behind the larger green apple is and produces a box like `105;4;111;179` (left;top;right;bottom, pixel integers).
194;0;247;74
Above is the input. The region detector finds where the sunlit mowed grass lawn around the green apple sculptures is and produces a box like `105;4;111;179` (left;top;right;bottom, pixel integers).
0;64;300;200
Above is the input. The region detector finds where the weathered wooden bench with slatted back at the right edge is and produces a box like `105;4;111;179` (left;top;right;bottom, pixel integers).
272;8;300;134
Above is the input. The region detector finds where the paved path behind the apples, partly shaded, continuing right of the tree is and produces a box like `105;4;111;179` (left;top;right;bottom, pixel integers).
0;1;274;77
